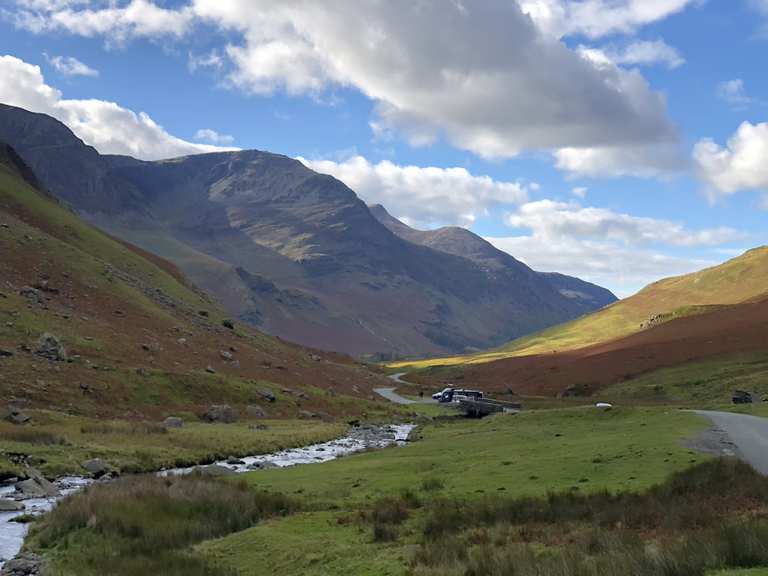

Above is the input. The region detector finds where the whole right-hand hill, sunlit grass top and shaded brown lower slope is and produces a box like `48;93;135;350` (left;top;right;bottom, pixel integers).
398;246;768;392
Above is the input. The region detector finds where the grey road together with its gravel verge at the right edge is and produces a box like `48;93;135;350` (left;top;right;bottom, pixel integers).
692;410;768;475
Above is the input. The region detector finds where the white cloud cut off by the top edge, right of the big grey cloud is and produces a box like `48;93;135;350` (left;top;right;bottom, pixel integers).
520;0;698;38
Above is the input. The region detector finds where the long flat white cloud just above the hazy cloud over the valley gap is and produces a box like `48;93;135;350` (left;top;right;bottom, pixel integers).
505;200;744;247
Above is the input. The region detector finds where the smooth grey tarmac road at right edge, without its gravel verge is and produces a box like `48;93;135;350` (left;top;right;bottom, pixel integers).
696;410;768;475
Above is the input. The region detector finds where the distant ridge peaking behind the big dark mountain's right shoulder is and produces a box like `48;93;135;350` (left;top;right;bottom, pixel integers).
369;204;616;314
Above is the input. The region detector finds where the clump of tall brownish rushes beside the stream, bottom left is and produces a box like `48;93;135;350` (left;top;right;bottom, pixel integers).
32;475;295;576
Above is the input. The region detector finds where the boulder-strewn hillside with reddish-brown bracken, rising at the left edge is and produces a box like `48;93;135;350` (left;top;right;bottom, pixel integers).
0;143;387;418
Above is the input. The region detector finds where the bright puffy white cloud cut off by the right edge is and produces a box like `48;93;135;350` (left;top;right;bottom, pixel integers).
693;122;768;195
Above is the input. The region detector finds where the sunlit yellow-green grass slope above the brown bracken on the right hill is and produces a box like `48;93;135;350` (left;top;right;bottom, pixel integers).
390;246;768;370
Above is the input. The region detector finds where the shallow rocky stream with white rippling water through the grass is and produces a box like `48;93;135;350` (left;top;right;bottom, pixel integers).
0;424;414;568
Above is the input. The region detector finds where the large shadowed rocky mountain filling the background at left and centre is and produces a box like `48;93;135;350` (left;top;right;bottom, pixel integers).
0;105;616;357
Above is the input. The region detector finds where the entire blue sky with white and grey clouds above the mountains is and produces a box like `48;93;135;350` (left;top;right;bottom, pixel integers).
0;0;768;297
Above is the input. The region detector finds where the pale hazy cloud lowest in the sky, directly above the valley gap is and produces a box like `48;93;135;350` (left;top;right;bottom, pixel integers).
486;236;717;298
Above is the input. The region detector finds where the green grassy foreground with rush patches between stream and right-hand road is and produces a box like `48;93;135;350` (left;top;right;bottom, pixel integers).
19;406;768;576
